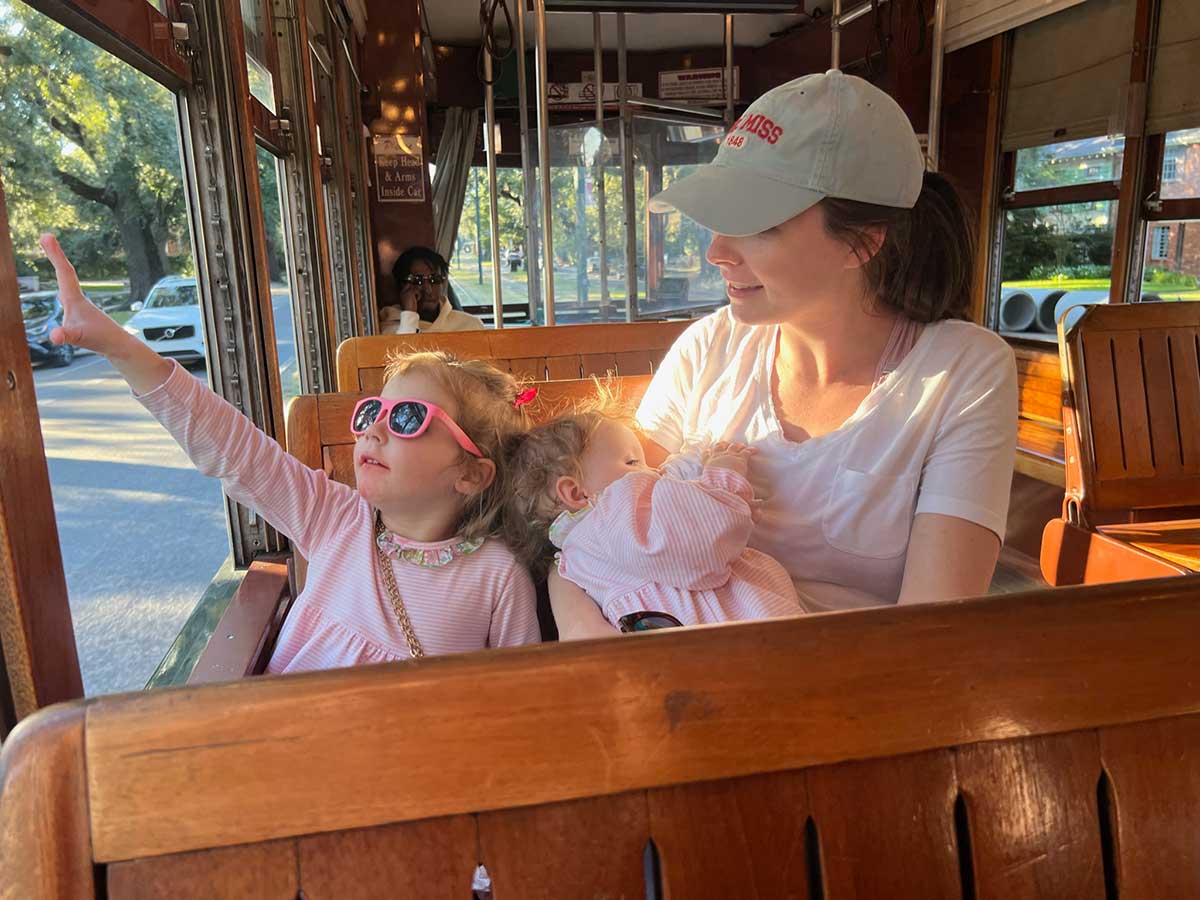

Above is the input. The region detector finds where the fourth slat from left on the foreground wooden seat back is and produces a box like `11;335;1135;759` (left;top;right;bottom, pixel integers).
649;772;809;900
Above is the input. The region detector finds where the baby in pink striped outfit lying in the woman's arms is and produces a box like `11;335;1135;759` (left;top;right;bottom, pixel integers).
505;388;802;640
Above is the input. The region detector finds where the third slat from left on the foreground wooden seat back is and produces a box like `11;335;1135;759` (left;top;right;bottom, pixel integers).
479;791;649;900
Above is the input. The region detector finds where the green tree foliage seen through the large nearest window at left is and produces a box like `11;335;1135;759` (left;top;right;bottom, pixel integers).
0;0;191;303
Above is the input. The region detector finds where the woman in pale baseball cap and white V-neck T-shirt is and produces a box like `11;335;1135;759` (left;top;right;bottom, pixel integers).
551;71;1016;637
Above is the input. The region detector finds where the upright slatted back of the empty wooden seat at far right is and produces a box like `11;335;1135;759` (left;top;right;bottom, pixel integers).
1058;302;1200;527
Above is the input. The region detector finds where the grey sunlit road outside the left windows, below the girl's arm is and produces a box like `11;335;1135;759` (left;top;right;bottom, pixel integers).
34;282;295;695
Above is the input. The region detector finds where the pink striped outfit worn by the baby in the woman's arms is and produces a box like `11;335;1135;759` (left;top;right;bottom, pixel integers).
556;467;802;625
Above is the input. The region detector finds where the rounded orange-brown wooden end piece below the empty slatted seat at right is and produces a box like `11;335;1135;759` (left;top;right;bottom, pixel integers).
1042;518;1188;587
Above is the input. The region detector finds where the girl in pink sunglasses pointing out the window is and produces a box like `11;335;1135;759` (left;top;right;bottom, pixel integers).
35;235;539;672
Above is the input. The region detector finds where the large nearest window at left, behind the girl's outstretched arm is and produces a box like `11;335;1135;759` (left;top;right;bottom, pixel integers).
0;0;229;695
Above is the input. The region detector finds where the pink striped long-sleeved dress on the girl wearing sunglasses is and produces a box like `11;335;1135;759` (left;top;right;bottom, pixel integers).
138;365;539;672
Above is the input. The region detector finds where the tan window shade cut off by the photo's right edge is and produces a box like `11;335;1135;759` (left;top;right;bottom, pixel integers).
1146;0;1200;134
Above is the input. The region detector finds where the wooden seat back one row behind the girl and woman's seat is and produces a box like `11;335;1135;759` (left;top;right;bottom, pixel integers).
337;320;691;392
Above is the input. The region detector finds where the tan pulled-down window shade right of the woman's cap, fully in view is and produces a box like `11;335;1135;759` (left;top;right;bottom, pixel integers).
1001;0;1132;150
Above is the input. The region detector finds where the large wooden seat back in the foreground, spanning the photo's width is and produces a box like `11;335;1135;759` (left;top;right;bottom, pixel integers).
7;577;1200;900
